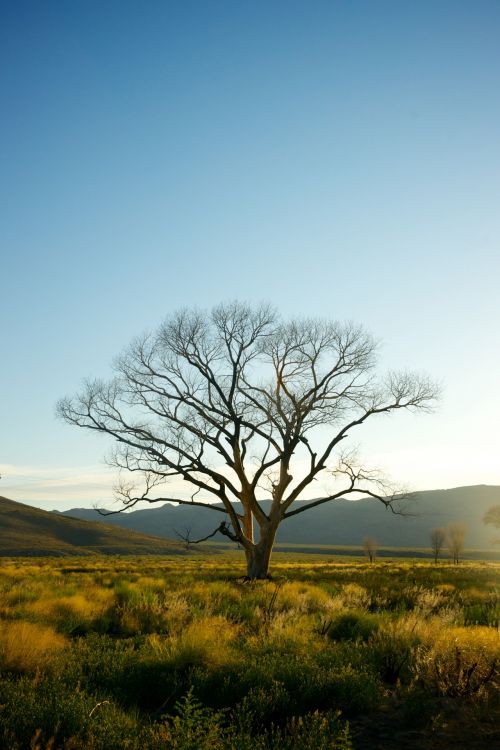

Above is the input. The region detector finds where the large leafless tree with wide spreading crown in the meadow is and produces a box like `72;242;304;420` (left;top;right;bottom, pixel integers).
57;302;437;578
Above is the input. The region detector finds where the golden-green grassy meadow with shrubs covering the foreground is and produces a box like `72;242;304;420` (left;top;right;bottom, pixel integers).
0;553;500;750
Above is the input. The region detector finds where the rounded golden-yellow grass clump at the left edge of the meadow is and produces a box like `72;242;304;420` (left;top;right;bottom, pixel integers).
0;621;66;672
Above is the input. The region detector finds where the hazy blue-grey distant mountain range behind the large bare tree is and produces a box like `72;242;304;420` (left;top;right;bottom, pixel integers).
59;485;500;549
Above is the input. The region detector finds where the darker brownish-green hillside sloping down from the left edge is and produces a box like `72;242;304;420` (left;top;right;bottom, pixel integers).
0;497;189;556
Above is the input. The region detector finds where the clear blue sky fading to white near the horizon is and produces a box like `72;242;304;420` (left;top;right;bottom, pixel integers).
0;0;500;507
